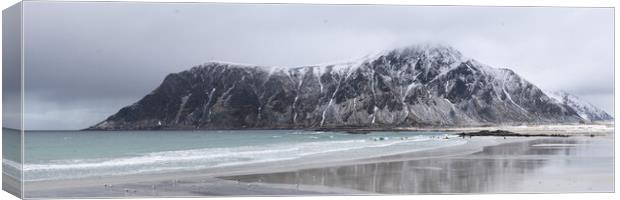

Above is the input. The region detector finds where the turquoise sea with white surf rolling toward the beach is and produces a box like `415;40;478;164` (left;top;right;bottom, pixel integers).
3;130;466;181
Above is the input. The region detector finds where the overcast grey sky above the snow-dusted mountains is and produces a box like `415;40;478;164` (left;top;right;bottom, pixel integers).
24;1;614;129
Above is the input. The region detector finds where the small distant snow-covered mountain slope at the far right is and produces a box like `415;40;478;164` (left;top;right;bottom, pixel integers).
545;91;614;122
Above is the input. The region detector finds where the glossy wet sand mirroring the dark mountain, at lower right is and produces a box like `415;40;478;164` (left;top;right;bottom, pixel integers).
223;138;613;194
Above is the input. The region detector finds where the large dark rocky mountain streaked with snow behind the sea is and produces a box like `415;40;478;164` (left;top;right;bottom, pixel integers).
90;45;609;130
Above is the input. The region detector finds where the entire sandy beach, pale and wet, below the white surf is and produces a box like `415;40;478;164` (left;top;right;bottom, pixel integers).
20;125;614;198
